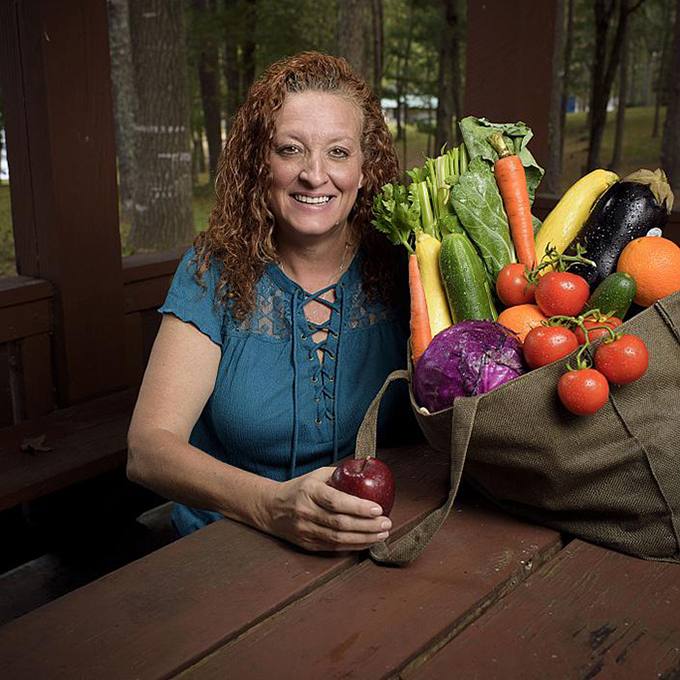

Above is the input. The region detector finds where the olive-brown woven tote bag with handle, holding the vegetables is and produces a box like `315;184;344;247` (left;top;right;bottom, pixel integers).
356;293;680;564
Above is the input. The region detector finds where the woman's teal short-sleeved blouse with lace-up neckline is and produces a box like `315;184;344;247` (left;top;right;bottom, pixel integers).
159;249;413;535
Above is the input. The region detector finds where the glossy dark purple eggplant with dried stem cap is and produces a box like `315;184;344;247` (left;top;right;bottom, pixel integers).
569;170;673;290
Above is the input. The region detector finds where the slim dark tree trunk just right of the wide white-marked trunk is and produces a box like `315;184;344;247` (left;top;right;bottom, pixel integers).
193;0;222;180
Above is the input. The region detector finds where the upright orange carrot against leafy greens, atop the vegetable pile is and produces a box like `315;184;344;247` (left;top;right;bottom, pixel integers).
487;132;536;269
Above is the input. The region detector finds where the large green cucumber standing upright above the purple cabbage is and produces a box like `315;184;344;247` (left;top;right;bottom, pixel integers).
439;234;498;323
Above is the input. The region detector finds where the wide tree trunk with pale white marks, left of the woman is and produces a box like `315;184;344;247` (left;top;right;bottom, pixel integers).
130;0;195;250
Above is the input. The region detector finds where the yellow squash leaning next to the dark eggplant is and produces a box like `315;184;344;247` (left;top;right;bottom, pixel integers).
536;169;618;263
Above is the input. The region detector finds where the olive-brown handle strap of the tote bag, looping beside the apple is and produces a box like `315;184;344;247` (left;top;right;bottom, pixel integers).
354;370;478;565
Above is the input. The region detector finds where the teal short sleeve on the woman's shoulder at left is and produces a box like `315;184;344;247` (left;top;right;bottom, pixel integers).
158;248;225;347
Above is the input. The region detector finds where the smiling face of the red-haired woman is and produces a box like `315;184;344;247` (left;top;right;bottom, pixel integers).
269;92;363;239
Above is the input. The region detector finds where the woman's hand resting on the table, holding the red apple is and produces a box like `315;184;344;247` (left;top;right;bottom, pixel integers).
267;467;392;551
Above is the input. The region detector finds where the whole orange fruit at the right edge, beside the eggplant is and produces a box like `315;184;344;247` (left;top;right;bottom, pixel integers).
616;236;680;307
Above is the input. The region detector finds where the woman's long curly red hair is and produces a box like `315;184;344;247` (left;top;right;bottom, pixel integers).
194;52;399;320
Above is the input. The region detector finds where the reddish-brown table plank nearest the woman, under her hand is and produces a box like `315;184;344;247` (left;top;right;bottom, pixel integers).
0;445;449;680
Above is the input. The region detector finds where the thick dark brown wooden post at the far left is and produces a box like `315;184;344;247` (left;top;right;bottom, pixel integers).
0;0;126;406
